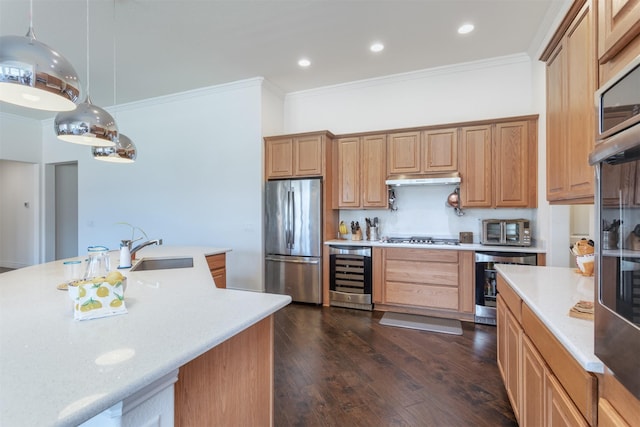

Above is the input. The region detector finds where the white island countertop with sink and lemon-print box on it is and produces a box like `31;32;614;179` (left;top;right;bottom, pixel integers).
0;246;291;427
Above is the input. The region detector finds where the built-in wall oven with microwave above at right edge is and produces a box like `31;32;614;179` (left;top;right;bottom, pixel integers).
589;53;640;399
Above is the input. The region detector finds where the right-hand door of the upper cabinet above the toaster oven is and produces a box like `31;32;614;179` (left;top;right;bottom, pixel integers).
496;121;537;208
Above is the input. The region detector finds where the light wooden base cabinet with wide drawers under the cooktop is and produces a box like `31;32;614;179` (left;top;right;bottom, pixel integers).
373;248;475;320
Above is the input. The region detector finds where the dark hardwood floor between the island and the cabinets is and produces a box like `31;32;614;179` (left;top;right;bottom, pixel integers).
274;304;517;427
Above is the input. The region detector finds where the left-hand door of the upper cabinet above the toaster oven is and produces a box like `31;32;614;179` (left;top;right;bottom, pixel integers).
460;125;493;208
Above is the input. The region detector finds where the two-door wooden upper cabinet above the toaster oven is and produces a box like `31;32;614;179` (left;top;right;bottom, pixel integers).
460;117;538;208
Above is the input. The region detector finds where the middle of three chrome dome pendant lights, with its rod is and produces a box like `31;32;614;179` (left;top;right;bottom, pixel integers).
54;0;118;147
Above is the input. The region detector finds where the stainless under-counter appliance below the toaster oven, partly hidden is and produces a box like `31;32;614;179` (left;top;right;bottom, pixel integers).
474;251;538;325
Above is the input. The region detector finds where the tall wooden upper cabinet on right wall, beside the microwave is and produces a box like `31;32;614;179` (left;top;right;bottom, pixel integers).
541;1;597;204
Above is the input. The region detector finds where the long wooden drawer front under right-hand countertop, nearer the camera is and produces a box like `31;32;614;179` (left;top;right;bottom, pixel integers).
524;304;597;425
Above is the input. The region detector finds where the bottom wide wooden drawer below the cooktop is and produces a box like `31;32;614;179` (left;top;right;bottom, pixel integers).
386;282;458;310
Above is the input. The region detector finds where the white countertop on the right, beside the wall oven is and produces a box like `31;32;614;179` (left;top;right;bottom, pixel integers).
496;264;604;373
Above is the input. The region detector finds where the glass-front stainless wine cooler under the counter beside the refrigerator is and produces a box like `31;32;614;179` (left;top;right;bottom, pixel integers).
329;246;373;311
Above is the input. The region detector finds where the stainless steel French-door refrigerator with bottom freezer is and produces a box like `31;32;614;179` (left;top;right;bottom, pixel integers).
265;178;322;304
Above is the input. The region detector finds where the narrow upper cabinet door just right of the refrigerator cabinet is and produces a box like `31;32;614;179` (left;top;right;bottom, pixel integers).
337;137;360;208
